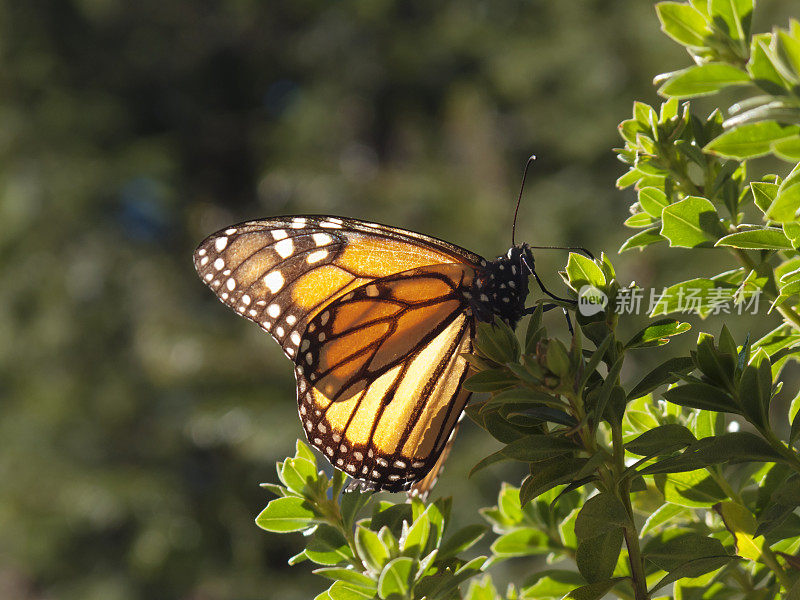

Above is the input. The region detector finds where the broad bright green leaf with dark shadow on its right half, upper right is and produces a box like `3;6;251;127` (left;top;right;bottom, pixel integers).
661;196;721;248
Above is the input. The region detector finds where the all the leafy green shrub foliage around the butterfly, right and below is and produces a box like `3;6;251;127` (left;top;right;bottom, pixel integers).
257;0;800;600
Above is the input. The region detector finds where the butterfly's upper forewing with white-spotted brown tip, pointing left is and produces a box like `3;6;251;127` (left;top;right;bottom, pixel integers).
194;216;483;359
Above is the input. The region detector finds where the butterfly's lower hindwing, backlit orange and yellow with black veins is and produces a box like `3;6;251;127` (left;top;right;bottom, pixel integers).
295;264;475;492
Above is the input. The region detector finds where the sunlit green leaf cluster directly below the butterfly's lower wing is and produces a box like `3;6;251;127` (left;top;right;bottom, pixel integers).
256;441;494;600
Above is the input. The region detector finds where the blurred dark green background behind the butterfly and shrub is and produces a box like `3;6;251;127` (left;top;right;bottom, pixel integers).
0;0;793;600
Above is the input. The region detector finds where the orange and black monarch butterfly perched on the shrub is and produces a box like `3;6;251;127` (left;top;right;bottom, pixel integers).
194;216;533;492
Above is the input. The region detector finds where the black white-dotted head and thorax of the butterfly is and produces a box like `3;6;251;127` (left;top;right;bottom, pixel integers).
470;244;533;327
